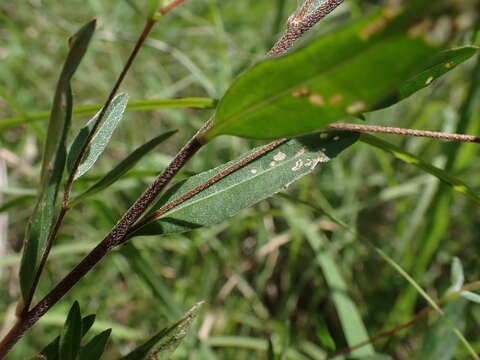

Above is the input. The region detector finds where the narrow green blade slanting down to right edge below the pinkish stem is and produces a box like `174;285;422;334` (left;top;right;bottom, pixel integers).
360;134;480;204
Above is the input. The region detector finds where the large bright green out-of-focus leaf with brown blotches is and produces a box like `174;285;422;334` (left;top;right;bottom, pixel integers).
206;0;462;139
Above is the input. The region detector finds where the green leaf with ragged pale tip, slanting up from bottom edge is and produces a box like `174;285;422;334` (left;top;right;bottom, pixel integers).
120;302;204;360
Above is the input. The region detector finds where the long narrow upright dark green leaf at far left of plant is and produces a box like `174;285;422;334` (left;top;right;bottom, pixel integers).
20;20;96;299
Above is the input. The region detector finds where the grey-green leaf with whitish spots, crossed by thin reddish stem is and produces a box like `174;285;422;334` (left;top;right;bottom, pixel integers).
130;132;358;235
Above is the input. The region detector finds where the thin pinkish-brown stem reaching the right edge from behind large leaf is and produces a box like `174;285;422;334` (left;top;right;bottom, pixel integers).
328;123;480;143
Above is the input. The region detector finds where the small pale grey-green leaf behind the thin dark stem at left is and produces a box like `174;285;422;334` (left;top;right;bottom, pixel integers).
67;93;128;179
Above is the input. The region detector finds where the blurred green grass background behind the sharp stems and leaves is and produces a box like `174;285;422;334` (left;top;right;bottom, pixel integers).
0;0;480;359
